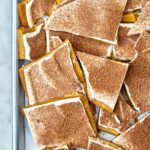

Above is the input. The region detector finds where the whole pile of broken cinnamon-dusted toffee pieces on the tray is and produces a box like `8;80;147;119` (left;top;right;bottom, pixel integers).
17;0;150;150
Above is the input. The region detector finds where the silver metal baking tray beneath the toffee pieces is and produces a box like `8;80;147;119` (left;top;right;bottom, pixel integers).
12;0;131;150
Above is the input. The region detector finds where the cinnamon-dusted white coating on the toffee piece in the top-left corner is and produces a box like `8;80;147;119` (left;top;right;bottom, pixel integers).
26;0;55;27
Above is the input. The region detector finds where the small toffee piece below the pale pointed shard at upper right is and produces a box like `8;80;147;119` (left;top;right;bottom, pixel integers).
113;24;137;61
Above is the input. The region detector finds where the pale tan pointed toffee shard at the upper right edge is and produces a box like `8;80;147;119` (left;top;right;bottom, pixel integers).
128;1;150;35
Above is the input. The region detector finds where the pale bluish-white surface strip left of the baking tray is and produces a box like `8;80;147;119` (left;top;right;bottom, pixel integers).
0;0;12;150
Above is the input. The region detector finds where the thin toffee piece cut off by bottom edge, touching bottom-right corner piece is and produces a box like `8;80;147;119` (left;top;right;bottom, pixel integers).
87;137;123;150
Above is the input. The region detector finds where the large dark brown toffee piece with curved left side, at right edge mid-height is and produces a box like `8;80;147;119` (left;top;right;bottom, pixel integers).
125;50;150;112
